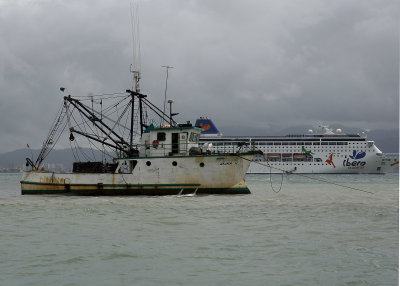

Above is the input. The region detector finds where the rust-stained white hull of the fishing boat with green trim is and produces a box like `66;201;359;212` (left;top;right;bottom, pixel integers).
21;155;253;195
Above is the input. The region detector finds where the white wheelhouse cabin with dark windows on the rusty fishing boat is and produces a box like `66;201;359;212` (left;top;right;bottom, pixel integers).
139;123;203;157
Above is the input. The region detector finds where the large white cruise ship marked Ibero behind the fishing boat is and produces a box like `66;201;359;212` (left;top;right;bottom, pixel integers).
195;117;399;174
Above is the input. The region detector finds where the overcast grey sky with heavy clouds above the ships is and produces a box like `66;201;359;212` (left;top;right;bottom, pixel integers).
0;0;399;152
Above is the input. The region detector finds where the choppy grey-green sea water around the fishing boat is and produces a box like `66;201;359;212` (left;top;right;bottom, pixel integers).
0;174;399;286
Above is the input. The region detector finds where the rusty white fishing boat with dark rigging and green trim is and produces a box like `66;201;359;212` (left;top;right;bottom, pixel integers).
21;90;254;195
